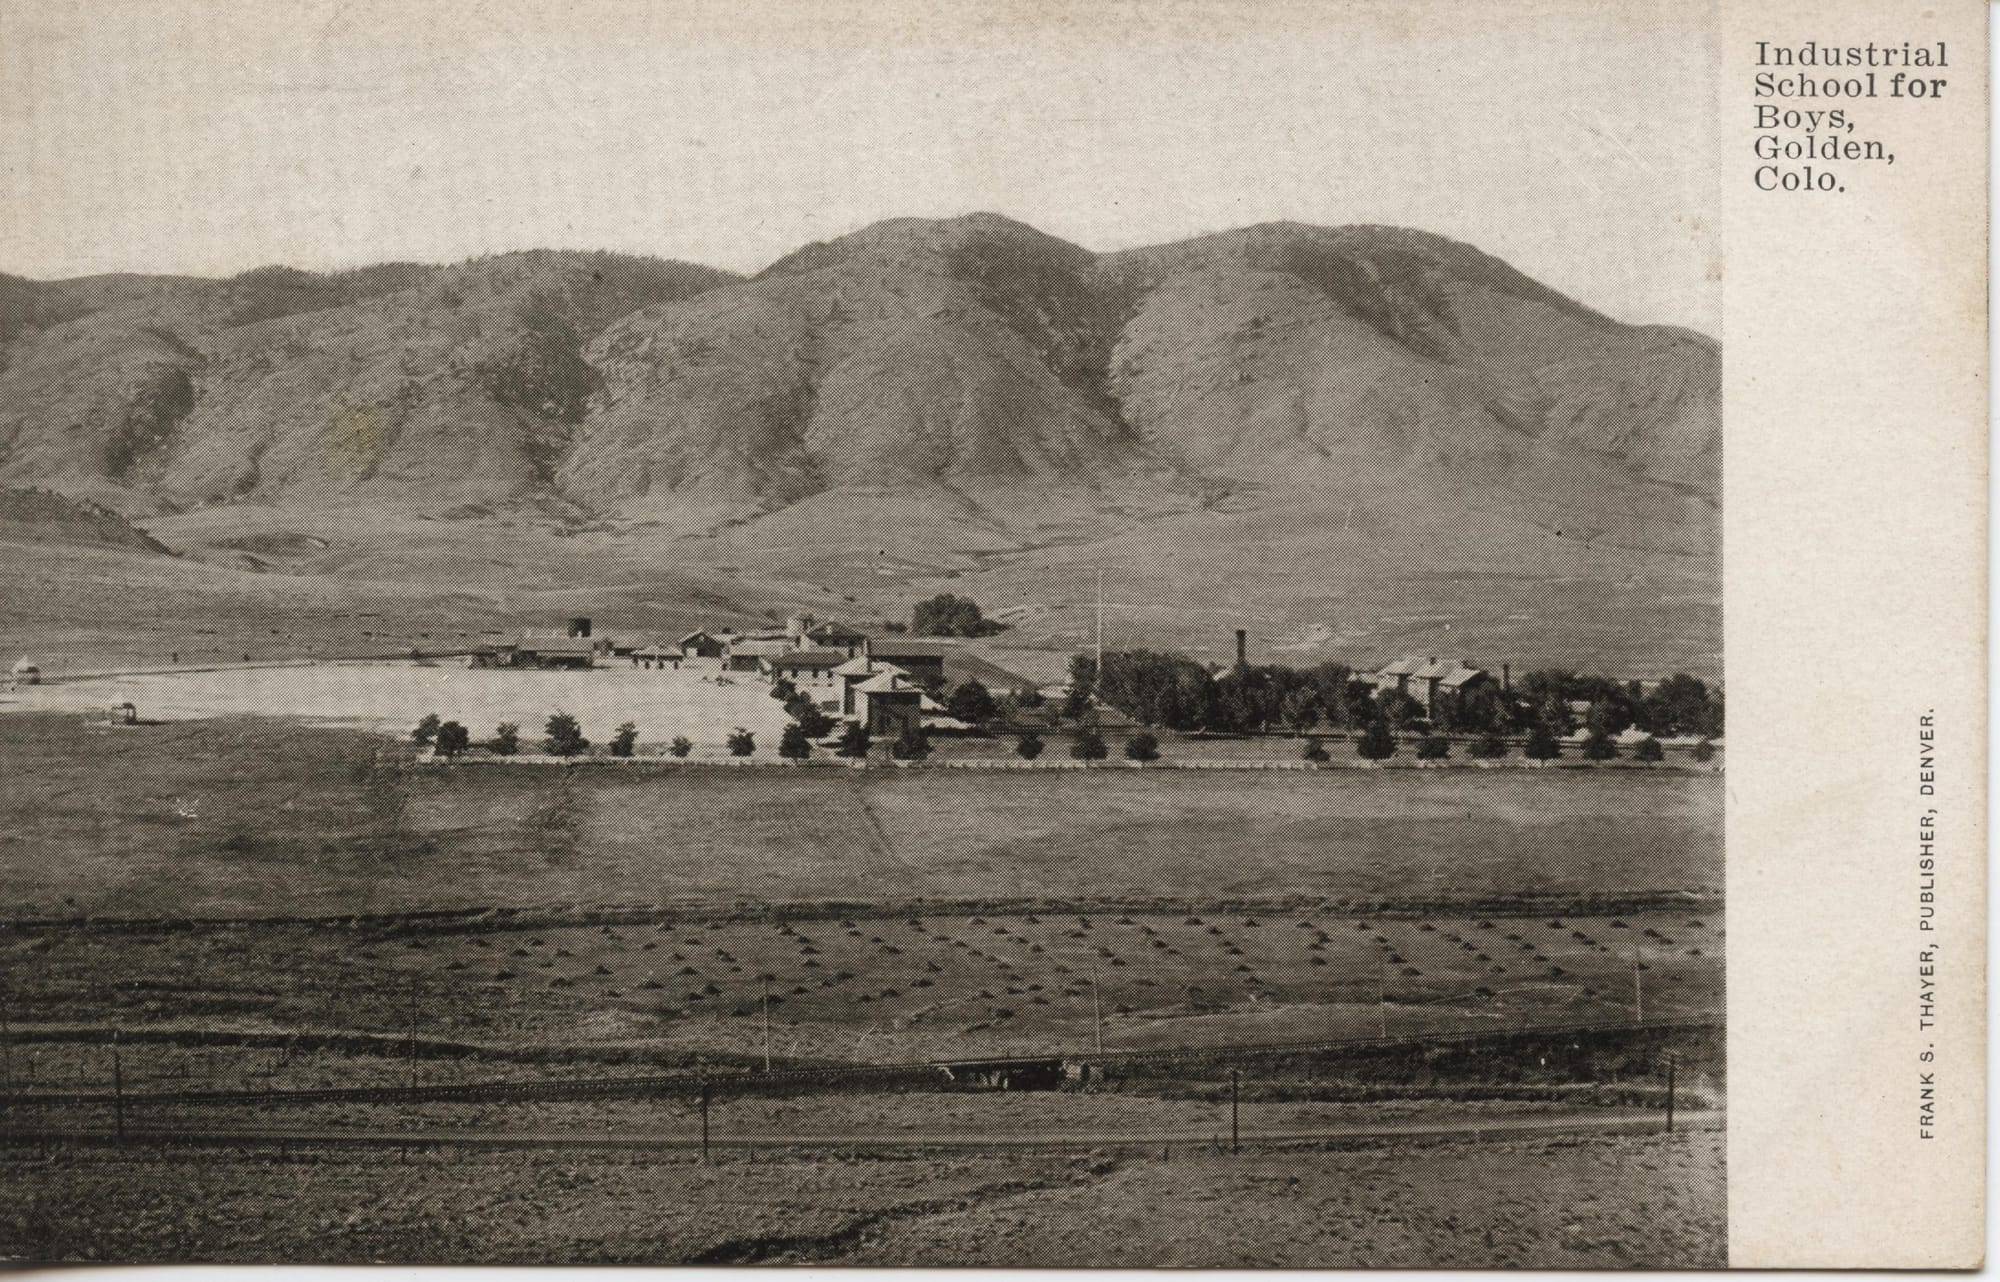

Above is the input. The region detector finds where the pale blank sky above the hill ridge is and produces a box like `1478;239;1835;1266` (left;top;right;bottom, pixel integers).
0;0;1720;334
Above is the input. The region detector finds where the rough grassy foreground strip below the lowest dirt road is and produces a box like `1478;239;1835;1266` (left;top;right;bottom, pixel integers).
0;1130;1724;1268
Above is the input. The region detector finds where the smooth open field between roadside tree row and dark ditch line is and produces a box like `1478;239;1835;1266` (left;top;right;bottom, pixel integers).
0;700;1722;918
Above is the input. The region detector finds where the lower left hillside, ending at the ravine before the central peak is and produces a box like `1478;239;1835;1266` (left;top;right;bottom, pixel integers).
0;252;730;512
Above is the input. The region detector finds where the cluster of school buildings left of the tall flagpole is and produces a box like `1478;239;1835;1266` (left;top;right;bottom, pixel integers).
472;614;1026;738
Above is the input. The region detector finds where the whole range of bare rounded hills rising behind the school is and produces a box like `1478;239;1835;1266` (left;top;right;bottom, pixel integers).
0;214;1720;556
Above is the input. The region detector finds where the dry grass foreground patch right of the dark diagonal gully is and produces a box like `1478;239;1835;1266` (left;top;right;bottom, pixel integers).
836;1132;1724;1268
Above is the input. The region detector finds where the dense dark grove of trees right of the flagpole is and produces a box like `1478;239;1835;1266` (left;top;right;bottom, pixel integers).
1064;650;1722;738
